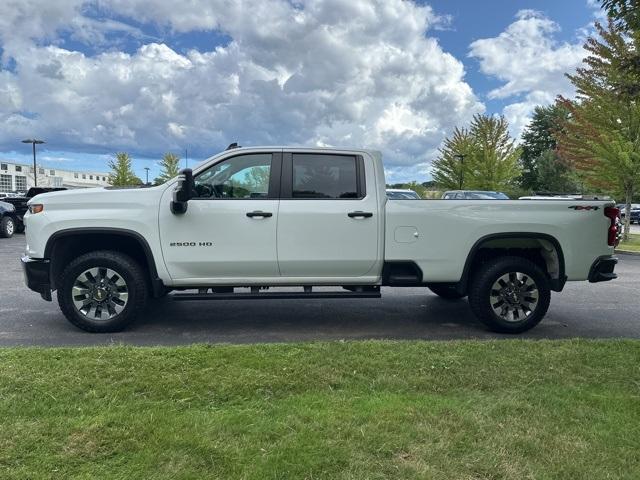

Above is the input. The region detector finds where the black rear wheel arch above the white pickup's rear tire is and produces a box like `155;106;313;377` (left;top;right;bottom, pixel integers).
459;232;567;292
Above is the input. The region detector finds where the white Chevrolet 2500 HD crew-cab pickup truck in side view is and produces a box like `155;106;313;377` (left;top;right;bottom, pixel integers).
22;147;619;333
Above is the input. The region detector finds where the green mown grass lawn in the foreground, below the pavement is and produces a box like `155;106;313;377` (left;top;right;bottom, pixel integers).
0;340;640;480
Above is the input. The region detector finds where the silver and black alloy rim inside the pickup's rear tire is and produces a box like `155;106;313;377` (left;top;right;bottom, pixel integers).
490;272;539;322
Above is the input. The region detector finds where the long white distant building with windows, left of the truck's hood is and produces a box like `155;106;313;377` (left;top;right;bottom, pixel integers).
0;160;109;192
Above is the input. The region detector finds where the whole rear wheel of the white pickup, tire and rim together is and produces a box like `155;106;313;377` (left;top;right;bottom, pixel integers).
469;256;551;333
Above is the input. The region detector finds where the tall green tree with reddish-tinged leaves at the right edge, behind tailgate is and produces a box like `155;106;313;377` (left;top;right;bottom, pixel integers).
558;20;640;239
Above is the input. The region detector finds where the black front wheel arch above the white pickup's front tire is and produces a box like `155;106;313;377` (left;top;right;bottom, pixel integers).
44;227;165;297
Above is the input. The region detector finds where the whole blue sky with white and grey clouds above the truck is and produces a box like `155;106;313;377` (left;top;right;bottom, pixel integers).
0;0;599;181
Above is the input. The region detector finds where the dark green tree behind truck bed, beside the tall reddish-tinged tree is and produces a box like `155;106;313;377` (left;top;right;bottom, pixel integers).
520;104;578;192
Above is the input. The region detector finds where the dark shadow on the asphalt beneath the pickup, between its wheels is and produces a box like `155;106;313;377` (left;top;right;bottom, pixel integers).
135;292;496;343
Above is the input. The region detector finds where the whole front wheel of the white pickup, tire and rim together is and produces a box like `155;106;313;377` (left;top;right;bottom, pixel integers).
57;250;148;332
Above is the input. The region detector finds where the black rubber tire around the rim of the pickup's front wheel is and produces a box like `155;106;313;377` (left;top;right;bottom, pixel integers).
56;250;148;333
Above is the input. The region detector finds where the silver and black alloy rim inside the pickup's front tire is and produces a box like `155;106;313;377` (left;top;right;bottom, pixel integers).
71;267;129;320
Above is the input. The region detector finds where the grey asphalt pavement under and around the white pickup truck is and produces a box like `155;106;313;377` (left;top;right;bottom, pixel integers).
0;235;640;346
